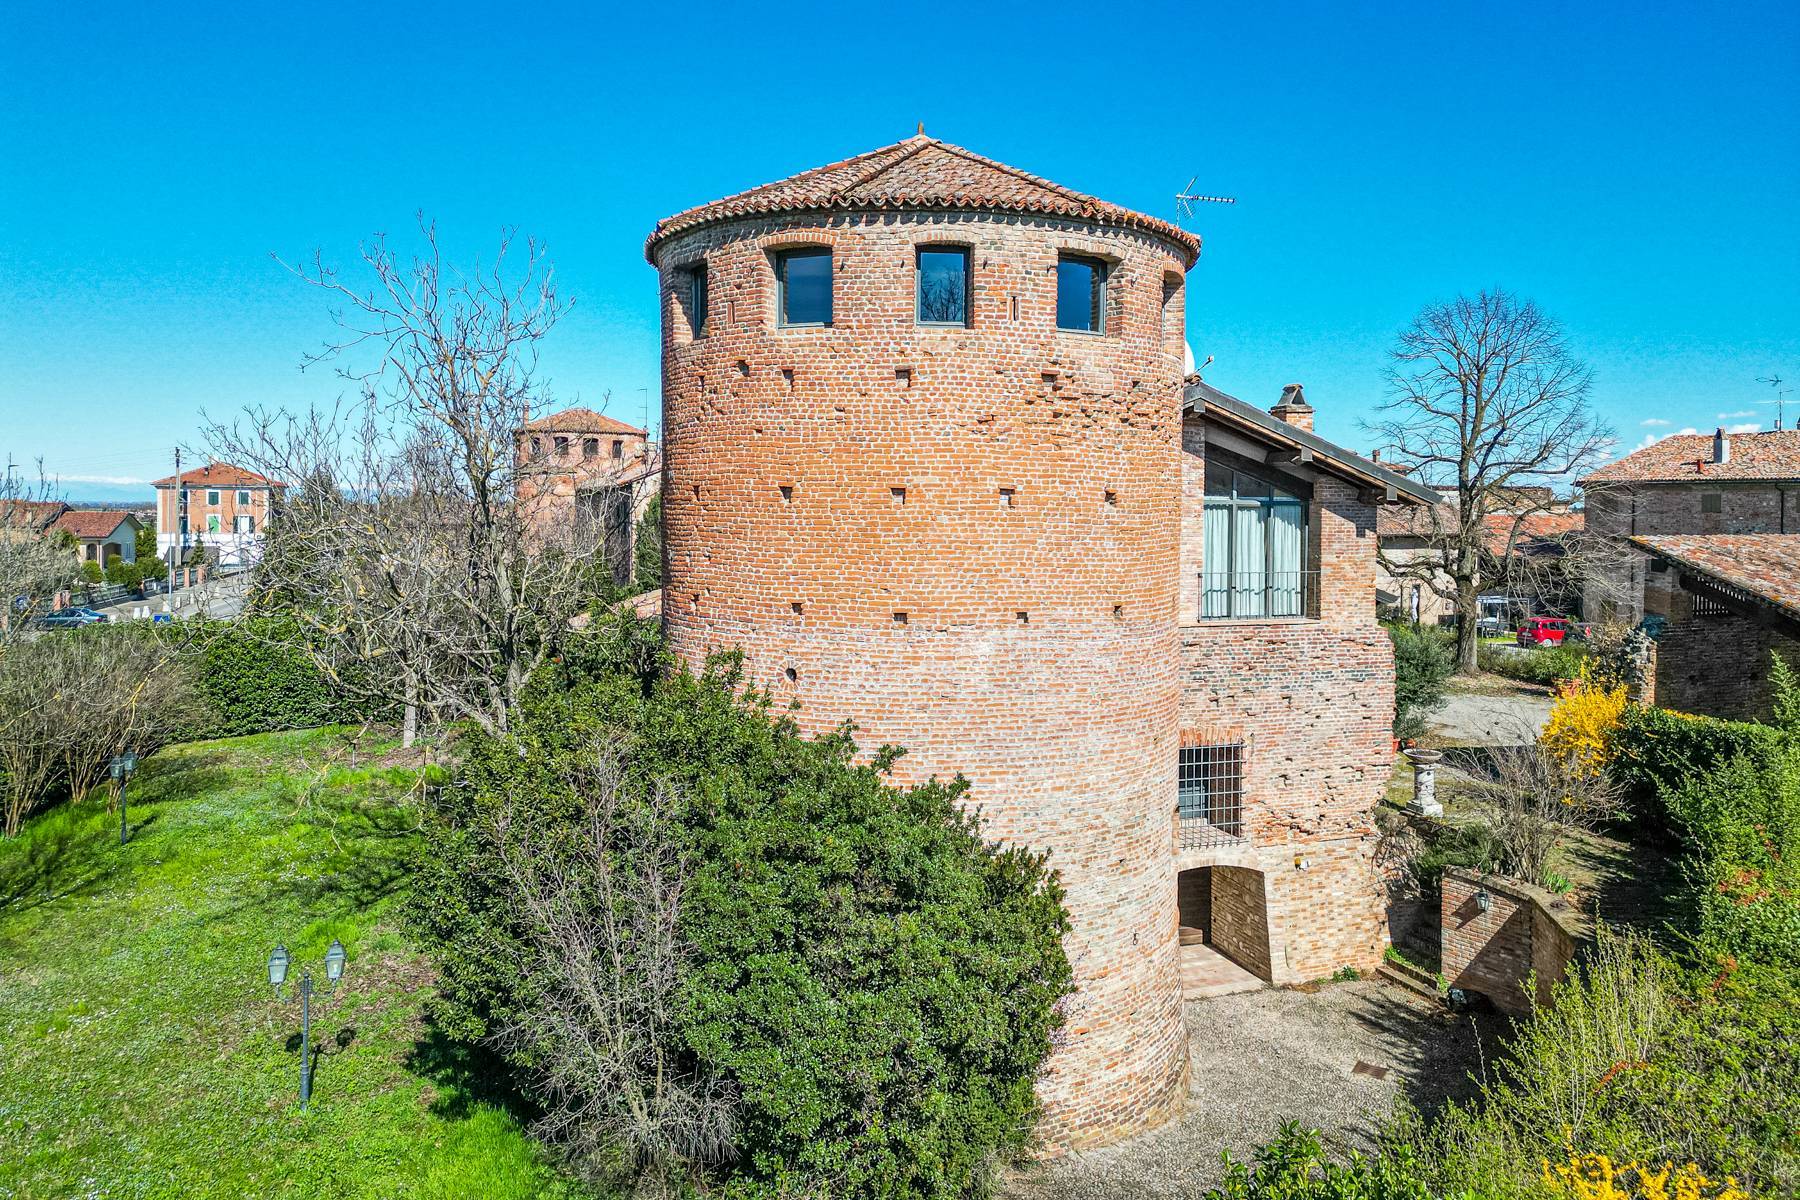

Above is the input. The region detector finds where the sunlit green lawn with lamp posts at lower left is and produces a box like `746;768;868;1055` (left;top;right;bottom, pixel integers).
0;730;576;1200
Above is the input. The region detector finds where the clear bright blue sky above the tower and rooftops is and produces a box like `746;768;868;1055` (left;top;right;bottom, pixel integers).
0;2;1800;497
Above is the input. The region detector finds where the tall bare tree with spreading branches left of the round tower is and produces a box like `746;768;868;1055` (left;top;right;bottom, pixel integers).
207;221;599;745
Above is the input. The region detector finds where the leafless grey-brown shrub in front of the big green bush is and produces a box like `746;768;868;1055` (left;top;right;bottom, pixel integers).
490;739;734;1191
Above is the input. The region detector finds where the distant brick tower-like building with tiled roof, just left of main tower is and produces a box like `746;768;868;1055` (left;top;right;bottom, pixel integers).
513;408;661;583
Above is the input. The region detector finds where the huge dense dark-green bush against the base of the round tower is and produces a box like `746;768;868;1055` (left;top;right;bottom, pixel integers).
412;637;1071;1196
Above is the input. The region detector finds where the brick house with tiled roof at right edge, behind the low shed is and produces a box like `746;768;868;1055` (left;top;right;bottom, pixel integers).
1580;428;1800;624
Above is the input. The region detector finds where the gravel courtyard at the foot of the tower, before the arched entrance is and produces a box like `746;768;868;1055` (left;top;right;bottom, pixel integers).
1003;981;1480;1200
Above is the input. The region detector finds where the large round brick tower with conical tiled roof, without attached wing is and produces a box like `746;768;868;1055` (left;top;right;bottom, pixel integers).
646;137;1199;1146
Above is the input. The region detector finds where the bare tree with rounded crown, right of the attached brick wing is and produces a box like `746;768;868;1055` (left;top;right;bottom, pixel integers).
1370;290;1613;673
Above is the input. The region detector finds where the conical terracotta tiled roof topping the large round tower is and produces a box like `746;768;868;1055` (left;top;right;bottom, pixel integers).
644;133;1201;266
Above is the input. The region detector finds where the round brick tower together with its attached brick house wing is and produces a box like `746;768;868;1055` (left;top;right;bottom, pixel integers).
646;135;1435;1146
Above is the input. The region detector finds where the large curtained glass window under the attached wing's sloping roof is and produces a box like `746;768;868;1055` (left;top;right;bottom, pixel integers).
1201;462;1310;617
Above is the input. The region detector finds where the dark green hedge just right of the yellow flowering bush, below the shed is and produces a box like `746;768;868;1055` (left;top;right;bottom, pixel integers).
1607;703;1782;842
